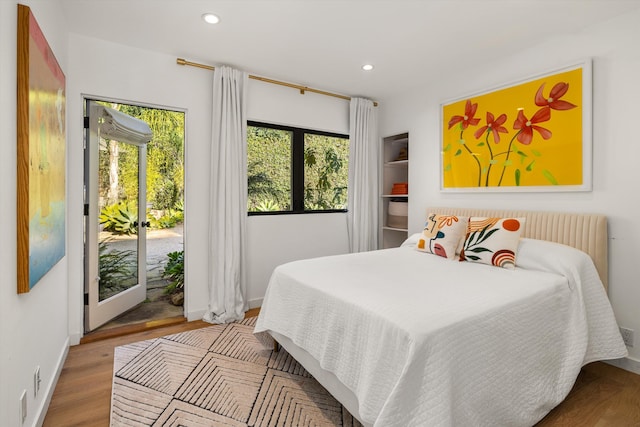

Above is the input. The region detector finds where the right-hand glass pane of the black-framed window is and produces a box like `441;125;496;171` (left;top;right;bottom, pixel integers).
304;133;349;210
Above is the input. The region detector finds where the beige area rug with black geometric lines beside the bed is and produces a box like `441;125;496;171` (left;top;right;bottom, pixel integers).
111;317;361;427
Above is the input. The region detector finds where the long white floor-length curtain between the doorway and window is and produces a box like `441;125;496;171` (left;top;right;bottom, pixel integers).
204;66;248;323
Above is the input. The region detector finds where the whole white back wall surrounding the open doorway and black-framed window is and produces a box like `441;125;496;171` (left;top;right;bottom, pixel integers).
68;34;349;332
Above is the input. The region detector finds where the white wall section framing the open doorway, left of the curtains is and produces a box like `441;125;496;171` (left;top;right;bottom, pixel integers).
67;34;212;338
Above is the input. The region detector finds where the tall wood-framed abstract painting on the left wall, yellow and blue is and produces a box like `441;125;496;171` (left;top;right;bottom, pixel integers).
16;5;66;293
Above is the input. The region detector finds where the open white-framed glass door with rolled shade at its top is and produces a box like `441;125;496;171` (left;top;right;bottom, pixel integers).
84;99;151;332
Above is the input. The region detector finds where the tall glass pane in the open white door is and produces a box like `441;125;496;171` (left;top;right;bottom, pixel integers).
98;138;138;301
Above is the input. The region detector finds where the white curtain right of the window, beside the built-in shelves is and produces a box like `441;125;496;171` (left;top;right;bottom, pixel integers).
347;98;380;252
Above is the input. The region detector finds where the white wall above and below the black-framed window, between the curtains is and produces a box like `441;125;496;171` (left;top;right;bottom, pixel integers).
247;80;349;308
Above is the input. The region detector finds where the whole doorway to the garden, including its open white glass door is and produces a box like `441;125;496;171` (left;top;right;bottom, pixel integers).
84;99;184;332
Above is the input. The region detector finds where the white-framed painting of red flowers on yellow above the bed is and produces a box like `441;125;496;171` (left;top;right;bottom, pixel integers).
440;60;592;192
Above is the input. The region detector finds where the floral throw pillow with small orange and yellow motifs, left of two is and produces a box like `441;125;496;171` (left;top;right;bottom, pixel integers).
416;213;469;259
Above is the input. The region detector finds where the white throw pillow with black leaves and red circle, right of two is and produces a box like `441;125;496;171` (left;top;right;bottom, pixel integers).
460;217;525;269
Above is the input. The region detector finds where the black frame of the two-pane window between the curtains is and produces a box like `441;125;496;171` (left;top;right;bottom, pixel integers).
247;120;350;216
